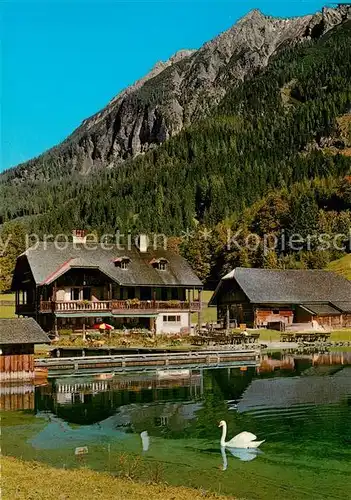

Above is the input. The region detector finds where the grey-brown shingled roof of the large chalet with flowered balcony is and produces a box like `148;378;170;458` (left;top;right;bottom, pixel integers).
15;243;202;288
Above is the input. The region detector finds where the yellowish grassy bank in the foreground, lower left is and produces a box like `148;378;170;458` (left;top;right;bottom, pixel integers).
1;457;228;500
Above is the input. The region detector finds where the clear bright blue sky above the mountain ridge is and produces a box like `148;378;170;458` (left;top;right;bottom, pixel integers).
0;0;325;170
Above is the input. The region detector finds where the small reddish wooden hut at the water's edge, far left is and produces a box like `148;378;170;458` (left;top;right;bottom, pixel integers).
0;318;50;381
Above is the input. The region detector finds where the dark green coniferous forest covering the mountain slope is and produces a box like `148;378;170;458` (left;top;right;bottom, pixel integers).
0;21;351;288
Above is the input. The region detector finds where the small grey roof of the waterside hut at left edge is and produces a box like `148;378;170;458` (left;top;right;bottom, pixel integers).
0;318;50;345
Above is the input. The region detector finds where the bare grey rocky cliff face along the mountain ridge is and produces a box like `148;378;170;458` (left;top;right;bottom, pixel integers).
7;6;351;178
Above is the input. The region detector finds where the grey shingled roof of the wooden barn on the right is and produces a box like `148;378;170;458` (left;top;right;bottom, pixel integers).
211;267;351;305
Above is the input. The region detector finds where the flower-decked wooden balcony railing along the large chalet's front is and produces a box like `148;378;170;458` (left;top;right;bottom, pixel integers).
40;299;201;313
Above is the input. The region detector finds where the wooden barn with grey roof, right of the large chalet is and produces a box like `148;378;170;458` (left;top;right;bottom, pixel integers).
210;268;351;328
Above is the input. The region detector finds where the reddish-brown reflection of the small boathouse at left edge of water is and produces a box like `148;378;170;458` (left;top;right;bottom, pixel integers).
0;383;34;411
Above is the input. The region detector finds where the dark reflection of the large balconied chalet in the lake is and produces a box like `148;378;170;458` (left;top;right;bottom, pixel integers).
36;370;203;424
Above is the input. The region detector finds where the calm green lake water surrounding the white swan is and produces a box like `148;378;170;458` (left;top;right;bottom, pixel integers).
2;352;351;500
